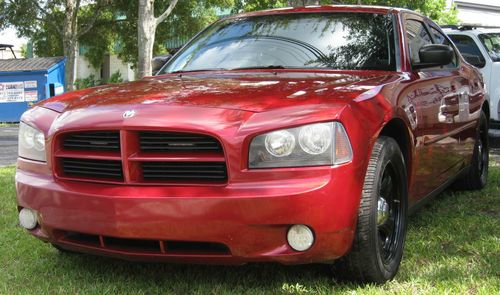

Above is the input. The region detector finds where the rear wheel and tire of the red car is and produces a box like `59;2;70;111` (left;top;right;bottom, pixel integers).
453;112;489;190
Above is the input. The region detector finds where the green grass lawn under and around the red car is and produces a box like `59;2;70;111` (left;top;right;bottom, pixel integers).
0;163;500;294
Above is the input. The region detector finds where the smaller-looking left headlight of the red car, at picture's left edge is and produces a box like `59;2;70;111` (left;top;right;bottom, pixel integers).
19;122;46;162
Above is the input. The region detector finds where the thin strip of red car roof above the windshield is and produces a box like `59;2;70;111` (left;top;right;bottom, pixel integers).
227;5;411;19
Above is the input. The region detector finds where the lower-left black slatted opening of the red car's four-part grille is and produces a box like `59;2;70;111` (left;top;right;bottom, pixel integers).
61;158;123;181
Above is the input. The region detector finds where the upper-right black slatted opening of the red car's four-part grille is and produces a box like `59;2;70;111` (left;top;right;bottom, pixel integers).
139;131;222;152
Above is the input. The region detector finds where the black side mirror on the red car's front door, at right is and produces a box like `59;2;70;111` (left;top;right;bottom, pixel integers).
412;44;455;69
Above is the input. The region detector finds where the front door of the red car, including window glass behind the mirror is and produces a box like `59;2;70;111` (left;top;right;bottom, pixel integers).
403;14;468;205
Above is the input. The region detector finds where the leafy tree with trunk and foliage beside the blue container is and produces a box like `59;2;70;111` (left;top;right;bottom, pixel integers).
0;0;110;90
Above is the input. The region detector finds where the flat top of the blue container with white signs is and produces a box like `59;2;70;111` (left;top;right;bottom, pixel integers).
0;57;64;72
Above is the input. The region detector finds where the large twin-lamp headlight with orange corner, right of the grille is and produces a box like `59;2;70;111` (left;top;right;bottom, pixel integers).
248;122;352;168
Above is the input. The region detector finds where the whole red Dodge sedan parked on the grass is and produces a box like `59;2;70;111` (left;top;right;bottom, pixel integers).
16;5;489;283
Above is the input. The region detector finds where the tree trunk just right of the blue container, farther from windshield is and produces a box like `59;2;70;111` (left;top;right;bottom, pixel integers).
62;0;80;91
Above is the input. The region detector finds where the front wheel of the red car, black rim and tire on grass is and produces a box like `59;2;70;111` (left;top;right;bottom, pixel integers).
334;136;408;284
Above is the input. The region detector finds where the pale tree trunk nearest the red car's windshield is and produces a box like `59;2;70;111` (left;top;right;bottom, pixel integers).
137;0;156;78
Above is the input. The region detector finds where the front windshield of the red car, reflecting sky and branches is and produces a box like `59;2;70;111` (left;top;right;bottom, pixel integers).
160;13;396;74
